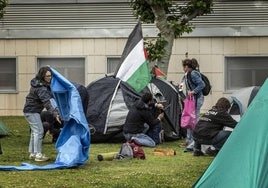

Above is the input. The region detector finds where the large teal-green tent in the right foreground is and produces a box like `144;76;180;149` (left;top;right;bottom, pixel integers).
193;79;268;188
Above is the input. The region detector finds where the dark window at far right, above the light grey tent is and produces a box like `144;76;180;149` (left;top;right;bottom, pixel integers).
225;56;268;91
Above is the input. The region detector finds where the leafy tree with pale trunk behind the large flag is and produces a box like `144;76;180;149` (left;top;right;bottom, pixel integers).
131;0;213;70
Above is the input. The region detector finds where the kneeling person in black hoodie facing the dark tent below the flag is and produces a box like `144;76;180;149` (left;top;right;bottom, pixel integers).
123;93;164;147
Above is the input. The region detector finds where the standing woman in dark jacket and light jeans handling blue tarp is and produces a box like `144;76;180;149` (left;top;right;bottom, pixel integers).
23;67;60;161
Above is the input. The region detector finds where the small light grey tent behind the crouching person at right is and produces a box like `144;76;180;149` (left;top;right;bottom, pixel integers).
229;86;260;120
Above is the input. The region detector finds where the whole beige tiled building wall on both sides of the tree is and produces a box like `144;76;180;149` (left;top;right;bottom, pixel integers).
0;37;268;116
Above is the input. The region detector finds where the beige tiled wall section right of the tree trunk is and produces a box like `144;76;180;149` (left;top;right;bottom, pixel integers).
168;37;268;111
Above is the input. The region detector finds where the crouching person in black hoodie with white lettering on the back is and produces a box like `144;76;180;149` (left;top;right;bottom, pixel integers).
193;97;237;156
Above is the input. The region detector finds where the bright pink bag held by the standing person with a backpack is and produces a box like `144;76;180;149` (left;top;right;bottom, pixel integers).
181;96;197;130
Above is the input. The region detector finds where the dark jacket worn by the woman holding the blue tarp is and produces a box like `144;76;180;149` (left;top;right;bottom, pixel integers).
23;78;57;115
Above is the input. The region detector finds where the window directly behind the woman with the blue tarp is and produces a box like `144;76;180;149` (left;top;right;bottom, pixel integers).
37;58;85;85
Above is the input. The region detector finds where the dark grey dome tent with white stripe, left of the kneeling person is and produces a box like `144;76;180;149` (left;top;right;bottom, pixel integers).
86;76;140;142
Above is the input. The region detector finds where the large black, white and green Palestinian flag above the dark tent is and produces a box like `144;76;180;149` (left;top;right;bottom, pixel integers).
115;23;151;93
